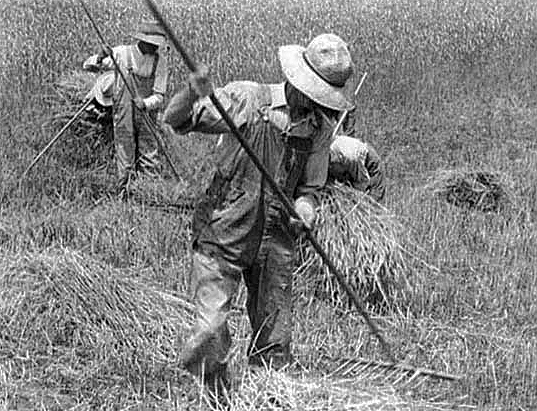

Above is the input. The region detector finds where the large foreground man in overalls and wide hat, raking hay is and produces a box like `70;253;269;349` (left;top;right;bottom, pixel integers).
164;34;353;400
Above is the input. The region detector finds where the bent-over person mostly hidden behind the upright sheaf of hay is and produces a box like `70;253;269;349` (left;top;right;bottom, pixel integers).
328;135;386;202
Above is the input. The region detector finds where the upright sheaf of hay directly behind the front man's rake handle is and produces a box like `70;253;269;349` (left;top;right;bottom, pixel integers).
296;183;407;308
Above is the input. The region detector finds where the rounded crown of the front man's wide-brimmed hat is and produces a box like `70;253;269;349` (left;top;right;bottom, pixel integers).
304;34;354;87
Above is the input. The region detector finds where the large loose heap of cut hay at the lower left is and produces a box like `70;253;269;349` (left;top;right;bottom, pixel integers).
0;249;193;384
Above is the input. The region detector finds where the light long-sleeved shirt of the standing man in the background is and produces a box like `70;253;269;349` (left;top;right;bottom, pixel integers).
82;44;168;110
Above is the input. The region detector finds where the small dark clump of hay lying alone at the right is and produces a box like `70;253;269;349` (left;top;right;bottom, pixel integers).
425;169;514;212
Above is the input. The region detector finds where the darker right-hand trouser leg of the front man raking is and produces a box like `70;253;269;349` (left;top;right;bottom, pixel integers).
245;222;294;368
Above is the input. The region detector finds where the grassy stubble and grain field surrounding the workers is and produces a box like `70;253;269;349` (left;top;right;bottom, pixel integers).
0;0;537;410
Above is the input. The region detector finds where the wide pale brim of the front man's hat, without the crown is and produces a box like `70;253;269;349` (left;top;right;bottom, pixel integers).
278;45;354;111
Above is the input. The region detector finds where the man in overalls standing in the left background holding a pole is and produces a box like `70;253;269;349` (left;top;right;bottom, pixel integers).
83;22;168;195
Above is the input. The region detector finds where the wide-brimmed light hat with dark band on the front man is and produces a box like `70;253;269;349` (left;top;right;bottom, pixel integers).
278;34;354;111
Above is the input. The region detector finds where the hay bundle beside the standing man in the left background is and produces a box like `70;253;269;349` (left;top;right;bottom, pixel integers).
45;71;113;168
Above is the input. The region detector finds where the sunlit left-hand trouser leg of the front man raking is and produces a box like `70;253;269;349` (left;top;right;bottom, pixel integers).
182;250;241;383
